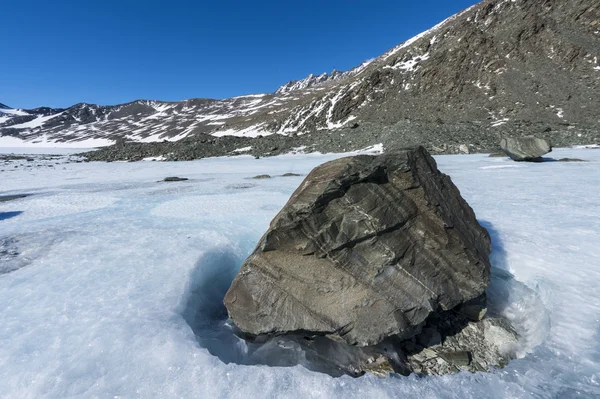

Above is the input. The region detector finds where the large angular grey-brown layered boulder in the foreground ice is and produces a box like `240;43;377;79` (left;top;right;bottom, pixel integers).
224;147;491;346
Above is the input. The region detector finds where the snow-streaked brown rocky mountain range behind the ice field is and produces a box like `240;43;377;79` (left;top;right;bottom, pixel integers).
0;0;600;150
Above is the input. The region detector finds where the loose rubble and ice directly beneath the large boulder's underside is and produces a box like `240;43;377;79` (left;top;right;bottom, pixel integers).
230;294;519;377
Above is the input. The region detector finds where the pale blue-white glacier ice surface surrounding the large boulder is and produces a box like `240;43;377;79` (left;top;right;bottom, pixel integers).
0;149;600;398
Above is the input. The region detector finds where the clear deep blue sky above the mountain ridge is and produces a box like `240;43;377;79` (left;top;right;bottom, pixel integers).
0;0;477;108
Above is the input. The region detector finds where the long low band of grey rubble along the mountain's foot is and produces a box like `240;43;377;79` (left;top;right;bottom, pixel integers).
78;121;598;161
